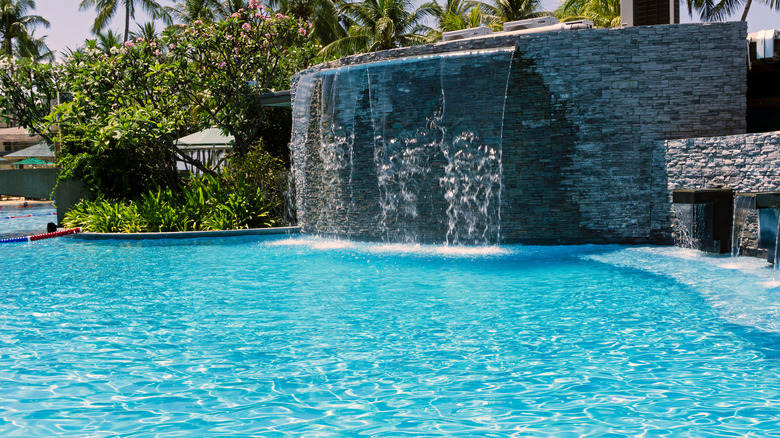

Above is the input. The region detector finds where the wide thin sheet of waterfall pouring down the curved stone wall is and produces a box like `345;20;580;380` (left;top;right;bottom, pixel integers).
291;49;514;244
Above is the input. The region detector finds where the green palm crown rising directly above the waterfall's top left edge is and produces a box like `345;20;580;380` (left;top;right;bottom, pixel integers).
320;0;432;56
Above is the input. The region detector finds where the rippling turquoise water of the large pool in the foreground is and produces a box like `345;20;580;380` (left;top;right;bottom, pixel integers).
0;237;780;437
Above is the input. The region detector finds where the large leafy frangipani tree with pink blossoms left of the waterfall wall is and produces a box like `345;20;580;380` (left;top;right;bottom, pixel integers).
0;1;319;198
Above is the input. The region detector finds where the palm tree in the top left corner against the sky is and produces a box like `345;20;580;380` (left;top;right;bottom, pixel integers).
0;0;50;57
